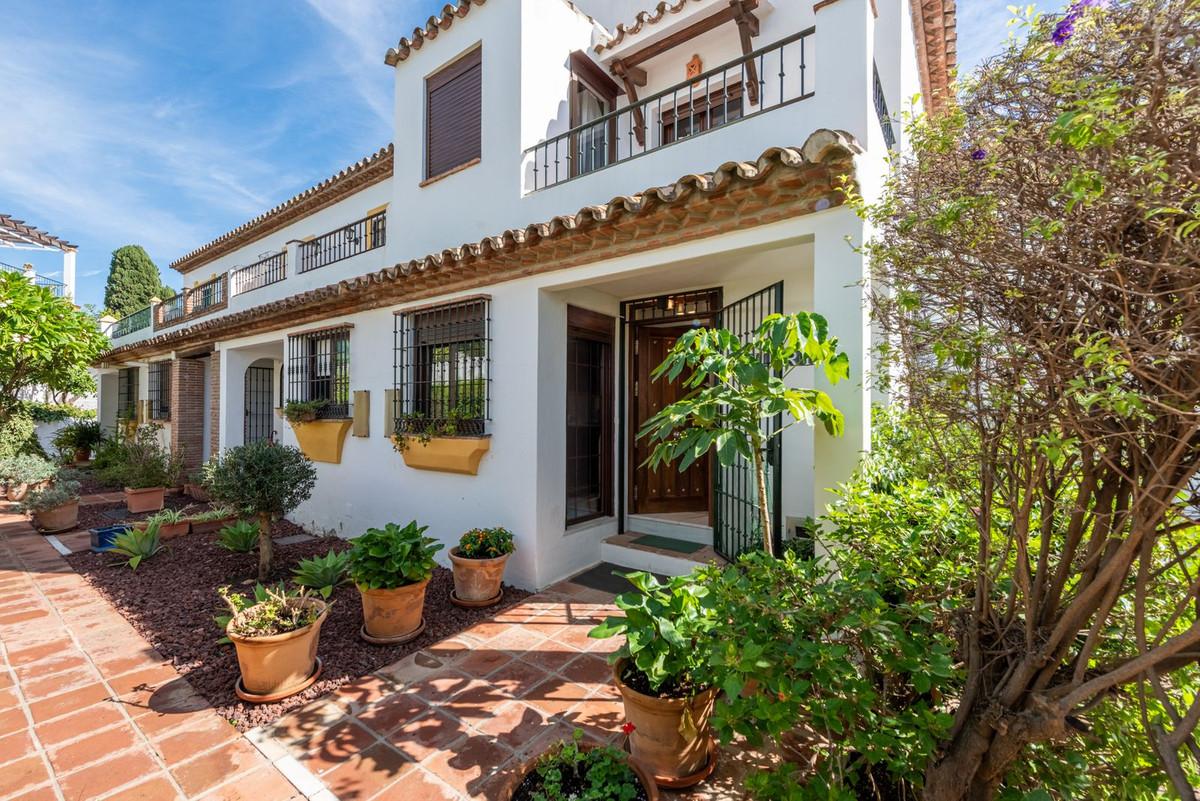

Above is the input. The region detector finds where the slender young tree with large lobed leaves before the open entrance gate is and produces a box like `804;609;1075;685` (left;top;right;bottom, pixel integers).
637;312;850;554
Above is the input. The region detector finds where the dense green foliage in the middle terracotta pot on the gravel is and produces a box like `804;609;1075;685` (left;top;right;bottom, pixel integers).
349;520;443;590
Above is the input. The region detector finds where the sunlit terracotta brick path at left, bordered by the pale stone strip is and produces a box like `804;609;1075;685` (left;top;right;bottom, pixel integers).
0;512;305;801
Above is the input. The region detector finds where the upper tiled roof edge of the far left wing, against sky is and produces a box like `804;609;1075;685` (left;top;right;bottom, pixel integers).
170;145;392;273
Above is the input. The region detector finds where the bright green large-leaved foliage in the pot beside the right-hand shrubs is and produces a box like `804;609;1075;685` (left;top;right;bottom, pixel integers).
588;573;714;698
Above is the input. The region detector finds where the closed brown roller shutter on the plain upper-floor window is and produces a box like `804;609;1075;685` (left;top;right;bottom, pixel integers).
425;48;484;177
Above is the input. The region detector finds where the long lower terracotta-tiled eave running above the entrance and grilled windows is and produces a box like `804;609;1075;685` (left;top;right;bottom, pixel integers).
102;128;862;361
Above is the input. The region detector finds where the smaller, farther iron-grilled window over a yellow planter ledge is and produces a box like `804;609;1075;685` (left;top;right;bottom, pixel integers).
286;325;350;420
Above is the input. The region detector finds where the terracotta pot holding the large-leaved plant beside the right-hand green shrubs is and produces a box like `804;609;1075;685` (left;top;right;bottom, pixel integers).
612;660;716;787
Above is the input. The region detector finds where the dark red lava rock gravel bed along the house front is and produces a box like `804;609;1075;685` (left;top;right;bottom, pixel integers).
67;520;529;731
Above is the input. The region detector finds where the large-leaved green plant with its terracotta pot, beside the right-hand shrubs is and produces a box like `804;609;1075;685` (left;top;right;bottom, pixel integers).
589;573;715;788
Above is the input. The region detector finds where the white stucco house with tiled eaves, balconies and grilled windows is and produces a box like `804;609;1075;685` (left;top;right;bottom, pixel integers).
93;0;954;588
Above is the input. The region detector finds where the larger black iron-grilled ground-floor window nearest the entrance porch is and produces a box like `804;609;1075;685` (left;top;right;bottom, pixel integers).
395;297;492;436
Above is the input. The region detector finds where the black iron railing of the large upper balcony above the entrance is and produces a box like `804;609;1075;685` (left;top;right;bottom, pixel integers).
524;28;816;192
